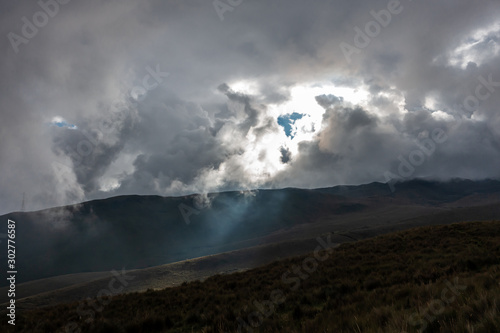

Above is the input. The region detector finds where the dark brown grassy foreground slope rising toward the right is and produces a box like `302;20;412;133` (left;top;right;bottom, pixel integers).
0;222;500;332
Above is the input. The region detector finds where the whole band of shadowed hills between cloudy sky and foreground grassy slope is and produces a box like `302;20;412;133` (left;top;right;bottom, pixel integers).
0;180;500;309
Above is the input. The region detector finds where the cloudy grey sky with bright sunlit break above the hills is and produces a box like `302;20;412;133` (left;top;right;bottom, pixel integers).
0;0;500;214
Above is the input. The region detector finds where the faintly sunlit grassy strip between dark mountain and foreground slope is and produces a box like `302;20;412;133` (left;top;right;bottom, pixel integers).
7;236;330;311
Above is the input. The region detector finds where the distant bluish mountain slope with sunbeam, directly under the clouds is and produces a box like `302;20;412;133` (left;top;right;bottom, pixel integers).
0;180;500;286
